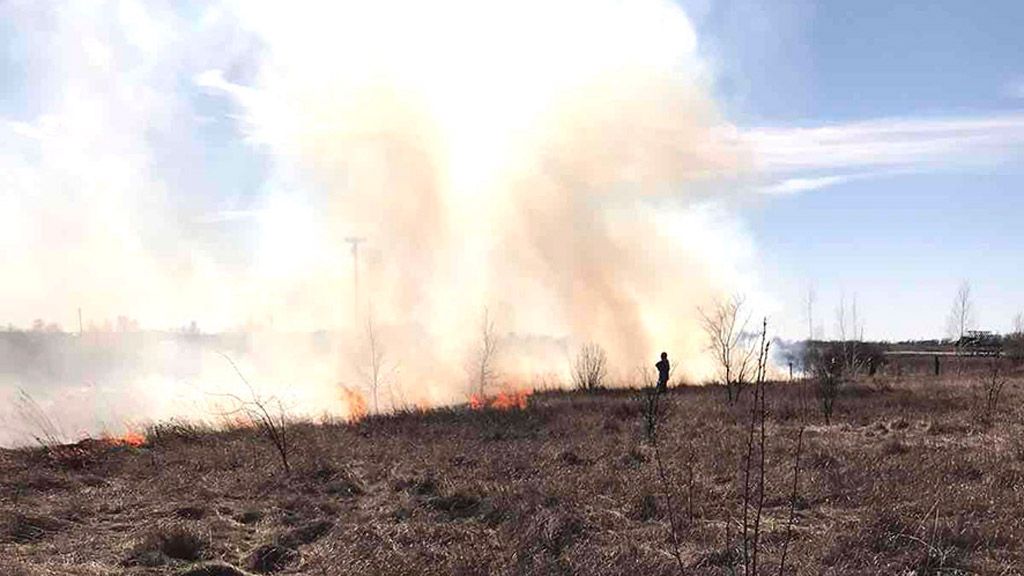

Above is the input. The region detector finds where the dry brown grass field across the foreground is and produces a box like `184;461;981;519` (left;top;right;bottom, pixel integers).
0;360;1024;576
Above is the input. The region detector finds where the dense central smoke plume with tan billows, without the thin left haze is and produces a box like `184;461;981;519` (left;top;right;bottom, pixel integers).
222;0;741;396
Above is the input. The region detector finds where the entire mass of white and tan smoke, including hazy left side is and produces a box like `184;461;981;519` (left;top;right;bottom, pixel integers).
0;0;753;442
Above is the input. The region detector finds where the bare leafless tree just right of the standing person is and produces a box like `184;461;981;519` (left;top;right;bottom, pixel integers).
697;296;758;403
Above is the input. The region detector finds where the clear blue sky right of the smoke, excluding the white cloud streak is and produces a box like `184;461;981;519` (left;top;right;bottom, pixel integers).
683;0;1024;338
